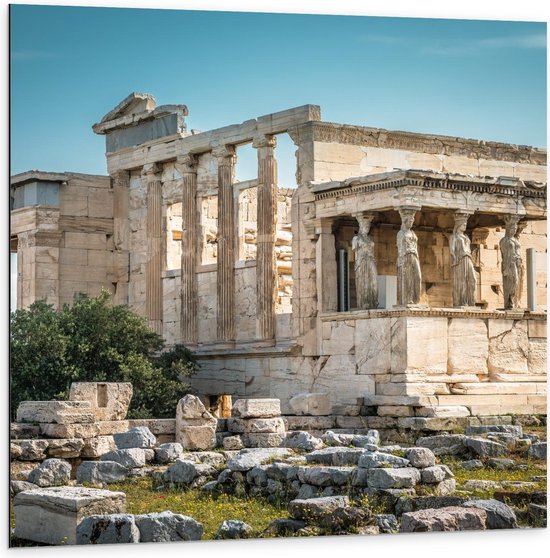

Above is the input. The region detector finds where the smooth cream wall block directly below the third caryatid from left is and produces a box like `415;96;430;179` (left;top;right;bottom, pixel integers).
448;318;489;374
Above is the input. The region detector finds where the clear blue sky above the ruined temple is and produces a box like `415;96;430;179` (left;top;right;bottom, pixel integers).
10;5;546;185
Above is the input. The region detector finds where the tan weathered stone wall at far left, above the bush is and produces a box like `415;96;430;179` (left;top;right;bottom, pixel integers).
11;172;114;308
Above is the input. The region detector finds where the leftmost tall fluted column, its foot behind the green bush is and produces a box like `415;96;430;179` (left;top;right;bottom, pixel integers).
142;164;163;335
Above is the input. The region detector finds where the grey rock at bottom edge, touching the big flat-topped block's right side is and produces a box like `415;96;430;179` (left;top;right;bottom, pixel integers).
76;513;140;544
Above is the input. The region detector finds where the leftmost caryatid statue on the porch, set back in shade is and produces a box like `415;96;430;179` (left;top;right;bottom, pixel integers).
351;213;378;309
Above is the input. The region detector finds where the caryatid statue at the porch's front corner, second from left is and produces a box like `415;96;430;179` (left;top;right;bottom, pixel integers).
397;207;422;306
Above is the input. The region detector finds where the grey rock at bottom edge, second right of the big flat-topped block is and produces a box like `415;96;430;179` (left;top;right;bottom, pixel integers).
135;511;204;542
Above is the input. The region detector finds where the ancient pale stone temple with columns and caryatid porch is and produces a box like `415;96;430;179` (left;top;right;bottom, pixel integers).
11;93;547;417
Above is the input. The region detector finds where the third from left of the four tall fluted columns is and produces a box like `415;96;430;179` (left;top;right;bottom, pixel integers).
212;145;236;342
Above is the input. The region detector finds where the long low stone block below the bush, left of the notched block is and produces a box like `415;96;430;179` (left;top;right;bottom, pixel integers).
16;401;95;426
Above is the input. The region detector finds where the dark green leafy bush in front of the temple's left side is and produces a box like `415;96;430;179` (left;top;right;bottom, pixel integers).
10;290;196;418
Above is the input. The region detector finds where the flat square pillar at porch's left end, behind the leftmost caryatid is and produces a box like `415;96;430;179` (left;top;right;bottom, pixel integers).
315;219;338;313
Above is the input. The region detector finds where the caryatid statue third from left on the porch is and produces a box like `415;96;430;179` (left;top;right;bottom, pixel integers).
449;212;476;306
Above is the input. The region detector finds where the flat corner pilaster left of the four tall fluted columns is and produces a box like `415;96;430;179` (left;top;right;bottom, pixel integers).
111;170;130;304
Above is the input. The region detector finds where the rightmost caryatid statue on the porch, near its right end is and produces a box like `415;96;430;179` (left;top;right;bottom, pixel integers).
500;215;525;310
